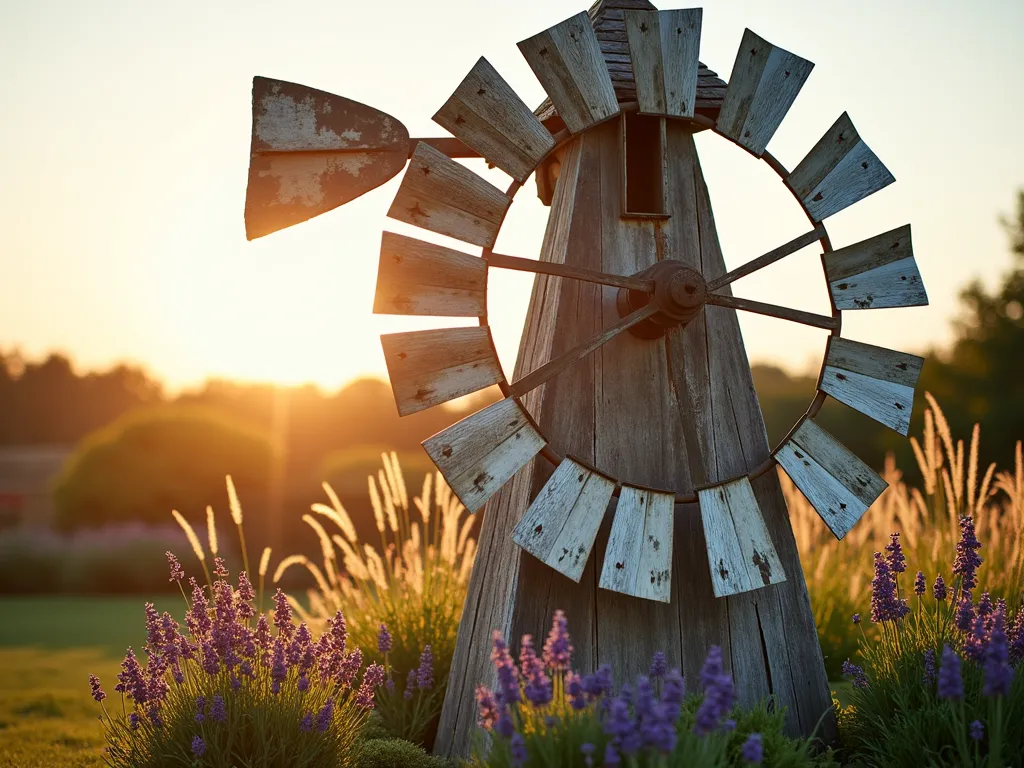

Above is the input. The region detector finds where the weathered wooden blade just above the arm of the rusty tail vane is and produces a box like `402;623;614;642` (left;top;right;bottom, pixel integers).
434;57;555;183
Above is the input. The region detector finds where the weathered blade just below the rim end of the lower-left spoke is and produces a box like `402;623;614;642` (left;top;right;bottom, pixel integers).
423;397;544;512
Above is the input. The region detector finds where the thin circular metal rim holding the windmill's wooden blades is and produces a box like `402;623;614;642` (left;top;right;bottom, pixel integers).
479;101;843;512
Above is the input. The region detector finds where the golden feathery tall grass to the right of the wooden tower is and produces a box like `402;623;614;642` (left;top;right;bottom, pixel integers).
779;393;1024;680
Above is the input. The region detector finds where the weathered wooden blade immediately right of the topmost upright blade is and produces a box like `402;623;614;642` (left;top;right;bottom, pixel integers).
718;30;814;157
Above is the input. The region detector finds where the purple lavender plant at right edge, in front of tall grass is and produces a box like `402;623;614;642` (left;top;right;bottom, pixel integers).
840;517;1024;768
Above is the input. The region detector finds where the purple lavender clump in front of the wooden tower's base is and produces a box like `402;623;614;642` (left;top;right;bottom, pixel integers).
474;611;835;768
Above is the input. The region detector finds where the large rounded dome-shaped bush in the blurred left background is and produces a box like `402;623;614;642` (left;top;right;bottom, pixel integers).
54;406;272;534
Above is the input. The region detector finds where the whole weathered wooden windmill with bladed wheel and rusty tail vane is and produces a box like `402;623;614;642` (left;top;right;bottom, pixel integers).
246;0;927;754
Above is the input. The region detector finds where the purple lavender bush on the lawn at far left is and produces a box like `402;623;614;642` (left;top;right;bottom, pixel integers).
90;552;384;768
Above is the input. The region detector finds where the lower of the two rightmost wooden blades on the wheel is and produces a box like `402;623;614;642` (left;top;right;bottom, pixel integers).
818;336;925;436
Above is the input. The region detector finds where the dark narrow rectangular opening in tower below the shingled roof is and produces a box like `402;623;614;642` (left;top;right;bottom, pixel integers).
622;113;668;218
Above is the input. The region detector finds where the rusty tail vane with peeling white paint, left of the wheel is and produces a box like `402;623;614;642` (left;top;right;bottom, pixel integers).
246;77;409;240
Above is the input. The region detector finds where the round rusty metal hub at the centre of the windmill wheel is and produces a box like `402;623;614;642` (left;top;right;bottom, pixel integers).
616;259;708;339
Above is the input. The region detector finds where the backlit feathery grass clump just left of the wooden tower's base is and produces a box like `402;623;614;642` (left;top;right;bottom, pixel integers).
273;453;476;750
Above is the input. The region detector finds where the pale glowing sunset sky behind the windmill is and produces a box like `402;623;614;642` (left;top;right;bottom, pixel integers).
0;0;1024;389
